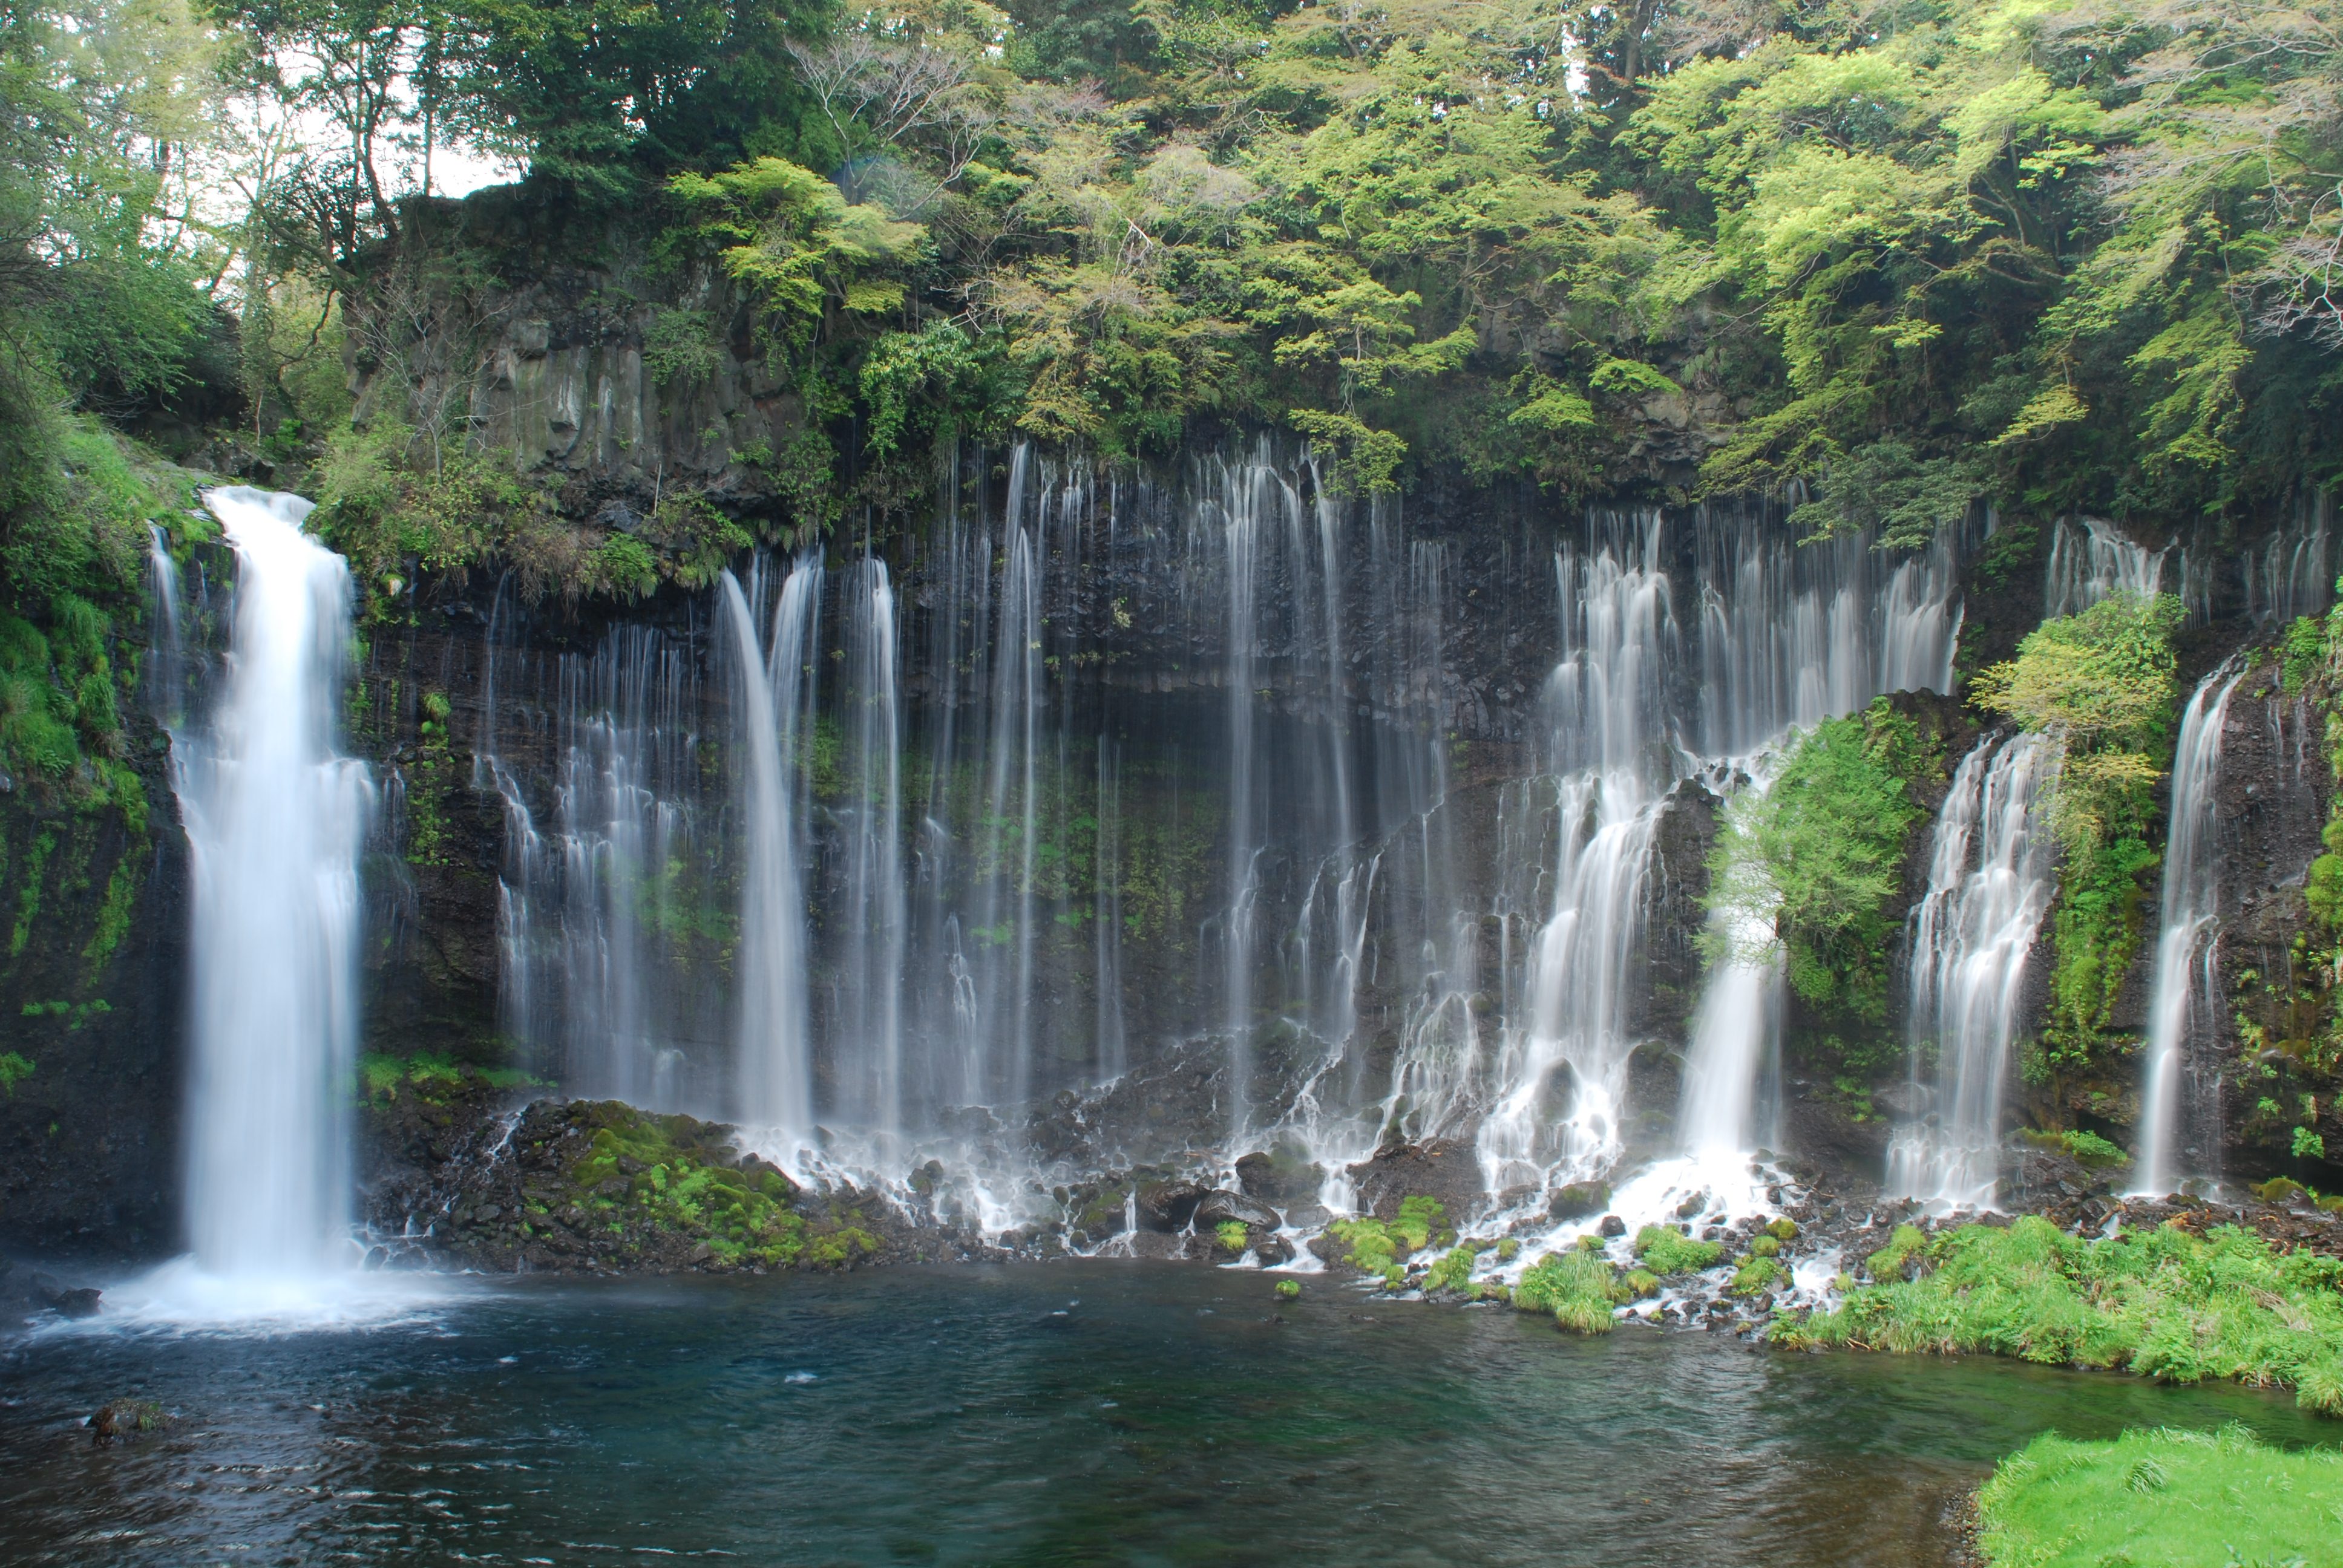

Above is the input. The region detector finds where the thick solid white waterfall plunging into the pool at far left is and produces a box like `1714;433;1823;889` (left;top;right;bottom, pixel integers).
171;488;373;1278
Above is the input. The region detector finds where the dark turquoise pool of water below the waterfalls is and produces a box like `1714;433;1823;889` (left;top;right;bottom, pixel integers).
0;1261;2336;1568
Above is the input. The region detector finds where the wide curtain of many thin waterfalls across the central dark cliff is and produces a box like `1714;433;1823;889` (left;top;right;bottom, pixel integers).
466;440;1961;1226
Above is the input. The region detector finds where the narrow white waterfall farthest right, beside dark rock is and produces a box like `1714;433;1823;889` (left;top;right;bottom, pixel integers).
2134;659;2244;1195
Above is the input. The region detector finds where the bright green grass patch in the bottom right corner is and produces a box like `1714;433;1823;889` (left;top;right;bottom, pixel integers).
1978;1425;2343;1568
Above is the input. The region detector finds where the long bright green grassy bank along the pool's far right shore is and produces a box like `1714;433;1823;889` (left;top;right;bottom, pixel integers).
1771;1214;2343;1416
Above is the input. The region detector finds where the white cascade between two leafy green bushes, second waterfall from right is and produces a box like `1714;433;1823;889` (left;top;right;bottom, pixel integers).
1886;736;2059;1207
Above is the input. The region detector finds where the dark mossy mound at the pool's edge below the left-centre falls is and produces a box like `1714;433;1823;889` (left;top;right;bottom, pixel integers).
562;1102;879;1268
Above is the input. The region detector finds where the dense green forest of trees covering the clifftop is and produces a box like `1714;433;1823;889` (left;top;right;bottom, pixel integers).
13;0;2343;600
